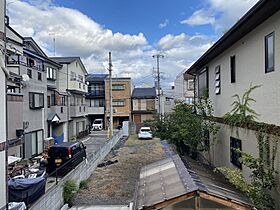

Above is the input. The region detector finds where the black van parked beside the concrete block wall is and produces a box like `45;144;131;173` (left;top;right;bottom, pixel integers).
46;142;86;176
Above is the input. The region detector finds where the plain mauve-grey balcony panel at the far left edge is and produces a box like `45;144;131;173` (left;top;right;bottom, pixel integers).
7;93;23;140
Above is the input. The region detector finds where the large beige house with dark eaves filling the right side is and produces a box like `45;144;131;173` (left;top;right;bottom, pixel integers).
187;0;280;201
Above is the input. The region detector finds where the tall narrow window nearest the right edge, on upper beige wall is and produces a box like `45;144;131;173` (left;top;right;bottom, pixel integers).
265;32;274;73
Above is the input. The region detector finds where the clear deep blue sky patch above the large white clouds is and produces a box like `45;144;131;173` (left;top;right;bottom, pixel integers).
54;0;214;43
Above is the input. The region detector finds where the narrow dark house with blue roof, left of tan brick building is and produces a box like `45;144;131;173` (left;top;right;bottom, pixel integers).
86;74;108;125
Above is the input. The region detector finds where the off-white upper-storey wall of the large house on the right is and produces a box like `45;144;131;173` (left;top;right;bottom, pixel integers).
208;12;280;125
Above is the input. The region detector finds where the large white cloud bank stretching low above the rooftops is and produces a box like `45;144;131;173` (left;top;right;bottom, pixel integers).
9;0;211;88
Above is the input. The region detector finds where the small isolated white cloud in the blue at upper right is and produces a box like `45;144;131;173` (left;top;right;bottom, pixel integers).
180;9;215;26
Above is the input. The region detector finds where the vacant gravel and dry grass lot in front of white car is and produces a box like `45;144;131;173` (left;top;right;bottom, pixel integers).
74;135;165;206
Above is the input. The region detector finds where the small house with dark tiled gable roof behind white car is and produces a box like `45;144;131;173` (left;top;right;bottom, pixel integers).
131;87;157;123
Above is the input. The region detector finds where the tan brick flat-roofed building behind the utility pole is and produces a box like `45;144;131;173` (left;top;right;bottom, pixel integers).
105;77;131;128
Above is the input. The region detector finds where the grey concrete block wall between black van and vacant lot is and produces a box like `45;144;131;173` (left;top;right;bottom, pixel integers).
30;131;122;210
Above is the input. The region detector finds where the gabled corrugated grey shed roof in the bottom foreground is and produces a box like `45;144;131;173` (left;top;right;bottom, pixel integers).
134;155;253;210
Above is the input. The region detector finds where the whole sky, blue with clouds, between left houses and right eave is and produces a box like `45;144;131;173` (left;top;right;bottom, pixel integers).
11;0;257;88
